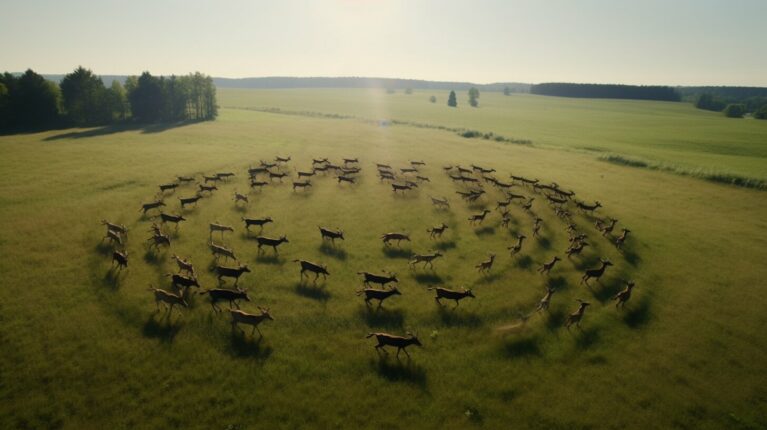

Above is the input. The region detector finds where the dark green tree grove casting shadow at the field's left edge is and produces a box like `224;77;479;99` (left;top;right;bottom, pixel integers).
0;67;218;131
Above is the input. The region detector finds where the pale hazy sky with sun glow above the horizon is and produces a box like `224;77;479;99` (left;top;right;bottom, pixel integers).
0;0;767;86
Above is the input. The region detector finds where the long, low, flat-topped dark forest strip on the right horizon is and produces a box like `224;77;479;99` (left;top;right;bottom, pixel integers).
530;82;681;101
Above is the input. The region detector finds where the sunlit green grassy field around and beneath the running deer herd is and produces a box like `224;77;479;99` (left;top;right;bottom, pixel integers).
0;95;767;429
